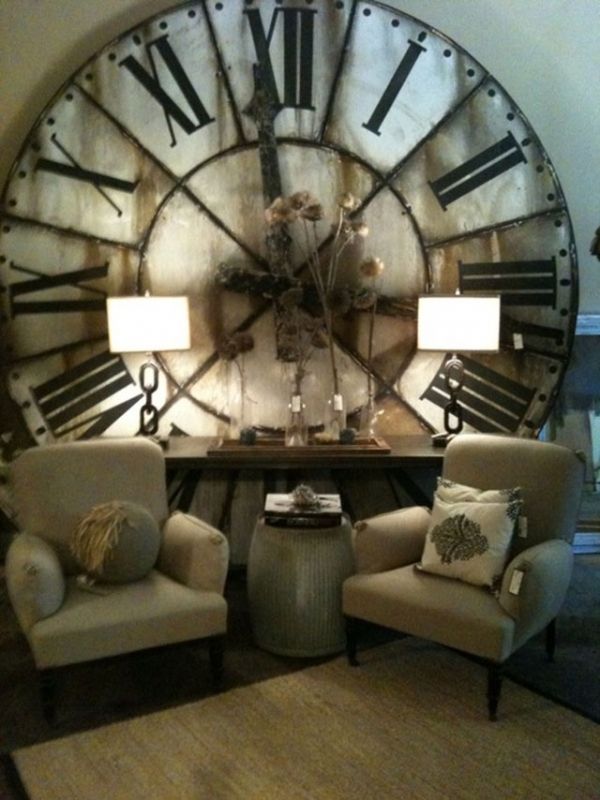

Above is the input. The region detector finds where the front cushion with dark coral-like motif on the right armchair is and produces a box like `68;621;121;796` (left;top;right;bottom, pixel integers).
419;497;518;587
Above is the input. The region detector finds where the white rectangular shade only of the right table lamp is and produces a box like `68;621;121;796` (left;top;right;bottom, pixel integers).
417;295;500;353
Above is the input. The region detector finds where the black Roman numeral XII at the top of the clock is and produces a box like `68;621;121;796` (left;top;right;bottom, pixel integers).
244;8;317;110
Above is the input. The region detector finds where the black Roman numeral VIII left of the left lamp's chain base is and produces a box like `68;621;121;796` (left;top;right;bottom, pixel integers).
32;352;143;439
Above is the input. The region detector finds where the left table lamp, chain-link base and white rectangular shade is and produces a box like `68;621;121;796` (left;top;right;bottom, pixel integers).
106;295;191;436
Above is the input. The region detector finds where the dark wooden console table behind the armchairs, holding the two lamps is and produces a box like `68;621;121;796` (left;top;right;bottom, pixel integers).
165;435;444;565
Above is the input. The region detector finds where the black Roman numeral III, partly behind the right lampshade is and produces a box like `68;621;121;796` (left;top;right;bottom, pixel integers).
458;258;556;308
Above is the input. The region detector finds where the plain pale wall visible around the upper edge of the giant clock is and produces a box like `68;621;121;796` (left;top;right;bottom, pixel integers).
0;0;600;313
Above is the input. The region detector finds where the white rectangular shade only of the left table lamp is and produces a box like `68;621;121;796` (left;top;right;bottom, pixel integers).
106;297;190;353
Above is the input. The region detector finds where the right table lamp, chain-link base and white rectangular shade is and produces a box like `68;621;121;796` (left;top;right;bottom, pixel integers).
417;294;500;447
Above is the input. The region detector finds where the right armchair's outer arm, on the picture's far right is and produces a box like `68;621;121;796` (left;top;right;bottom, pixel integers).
498;539;573;647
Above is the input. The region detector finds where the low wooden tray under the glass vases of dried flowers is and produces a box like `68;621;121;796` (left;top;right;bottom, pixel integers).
207;436;391;459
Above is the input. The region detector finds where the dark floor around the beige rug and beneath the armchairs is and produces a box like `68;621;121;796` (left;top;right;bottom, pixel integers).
0;555;600;797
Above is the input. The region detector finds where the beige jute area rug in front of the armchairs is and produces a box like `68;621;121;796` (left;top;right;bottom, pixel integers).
12;639;600;800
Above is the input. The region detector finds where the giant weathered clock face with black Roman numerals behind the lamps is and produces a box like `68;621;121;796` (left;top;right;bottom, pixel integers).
0;0;577;443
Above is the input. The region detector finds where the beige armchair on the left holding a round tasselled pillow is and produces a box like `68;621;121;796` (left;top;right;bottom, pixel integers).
6;438;229;720
